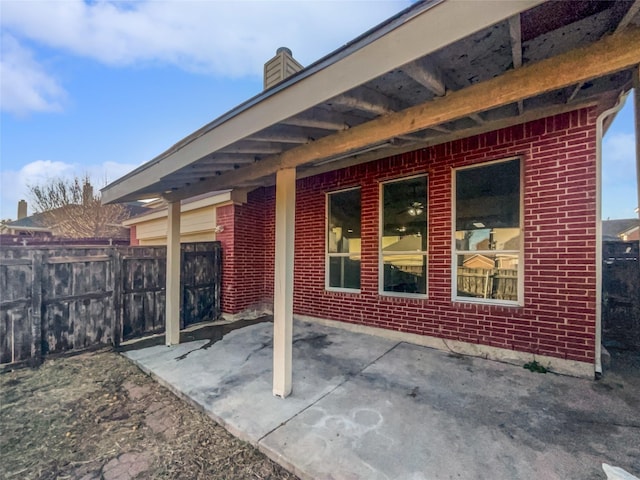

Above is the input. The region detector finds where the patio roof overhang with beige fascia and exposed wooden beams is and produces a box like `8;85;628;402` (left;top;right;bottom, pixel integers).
102;0;640;203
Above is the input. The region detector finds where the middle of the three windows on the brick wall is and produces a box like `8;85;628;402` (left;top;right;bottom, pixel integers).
380;175;427;296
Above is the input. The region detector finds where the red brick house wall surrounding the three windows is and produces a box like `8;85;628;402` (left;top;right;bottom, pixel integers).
239;109;596;362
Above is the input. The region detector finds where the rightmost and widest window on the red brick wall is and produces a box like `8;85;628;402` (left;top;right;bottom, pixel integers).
453;158;523;304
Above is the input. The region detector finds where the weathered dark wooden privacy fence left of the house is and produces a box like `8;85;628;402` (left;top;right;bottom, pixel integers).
0;242;222;364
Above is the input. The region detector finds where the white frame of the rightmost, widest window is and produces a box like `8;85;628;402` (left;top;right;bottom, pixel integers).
451;155;525;307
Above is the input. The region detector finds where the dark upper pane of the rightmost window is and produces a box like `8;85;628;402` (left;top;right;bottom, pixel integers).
456;160;520;232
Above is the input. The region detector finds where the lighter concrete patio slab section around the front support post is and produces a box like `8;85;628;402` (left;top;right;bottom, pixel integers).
126;323;396;444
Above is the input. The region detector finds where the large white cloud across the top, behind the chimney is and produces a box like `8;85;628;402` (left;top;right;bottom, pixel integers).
2;0;409;76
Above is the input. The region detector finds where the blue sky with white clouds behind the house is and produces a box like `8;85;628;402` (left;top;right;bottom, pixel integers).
0;0;637;219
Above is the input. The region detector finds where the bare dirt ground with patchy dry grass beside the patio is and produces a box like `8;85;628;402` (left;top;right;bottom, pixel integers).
0;350;297;480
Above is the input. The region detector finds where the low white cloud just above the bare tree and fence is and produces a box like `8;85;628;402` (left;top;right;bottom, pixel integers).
0;160;137;219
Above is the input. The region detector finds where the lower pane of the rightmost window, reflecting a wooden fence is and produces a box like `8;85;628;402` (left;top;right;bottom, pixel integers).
457;253;518;301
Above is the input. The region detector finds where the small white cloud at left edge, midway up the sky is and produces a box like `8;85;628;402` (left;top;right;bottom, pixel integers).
0;34;66;116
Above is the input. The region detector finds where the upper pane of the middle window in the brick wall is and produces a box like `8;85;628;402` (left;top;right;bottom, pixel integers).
381;177;427;252
